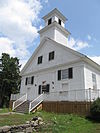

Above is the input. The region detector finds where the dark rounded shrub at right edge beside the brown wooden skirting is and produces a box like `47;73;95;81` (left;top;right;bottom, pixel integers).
90;98;100;120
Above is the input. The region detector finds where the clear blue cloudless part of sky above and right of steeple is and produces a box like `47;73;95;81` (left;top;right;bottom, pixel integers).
40;0;100;56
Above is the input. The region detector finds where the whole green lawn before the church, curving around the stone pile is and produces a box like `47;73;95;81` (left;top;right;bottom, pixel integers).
0;111;100;133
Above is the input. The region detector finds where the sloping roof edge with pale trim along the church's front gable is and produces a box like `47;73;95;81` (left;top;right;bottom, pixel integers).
20;37;100;75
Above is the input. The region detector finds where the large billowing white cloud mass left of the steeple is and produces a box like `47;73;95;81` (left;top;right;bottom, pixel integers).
0;0;46;68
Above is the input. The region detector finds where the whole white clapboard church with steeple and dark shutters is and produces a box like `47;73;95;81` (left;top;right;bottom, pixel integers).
11;9;100;112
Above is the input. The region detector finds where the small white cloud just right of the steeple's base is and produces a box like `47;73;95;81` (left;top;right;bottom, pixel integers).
67;37;89;50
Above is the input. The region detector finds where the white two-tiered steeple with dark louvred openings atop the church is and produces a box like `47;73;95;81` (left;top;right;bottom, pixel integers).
39;8;70;45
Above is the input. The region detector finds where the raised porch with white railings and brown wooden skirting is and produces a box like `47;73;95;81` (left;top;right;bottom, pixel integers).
11;89;100;113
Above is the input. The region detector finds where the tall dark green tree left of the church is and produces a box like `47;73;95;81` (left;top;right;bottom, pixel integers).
0;53;21;107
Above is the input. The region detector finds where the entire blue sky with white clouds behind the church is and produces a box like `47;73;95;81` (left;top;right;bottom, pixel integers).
0;0;100;65
